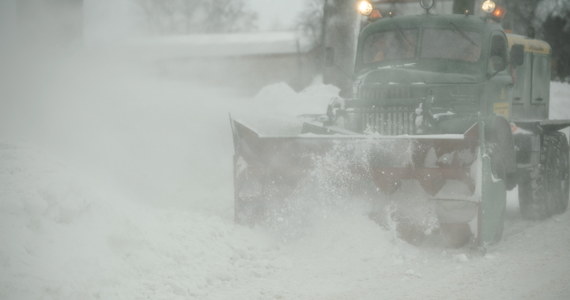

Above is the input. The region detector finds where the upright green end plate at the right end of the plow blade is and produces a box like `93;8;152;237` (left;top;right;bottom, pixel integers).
477;141;507;247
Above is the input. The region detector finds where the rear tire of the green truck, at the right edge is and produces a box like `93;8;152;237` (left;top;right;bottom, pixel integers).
519;132;570;220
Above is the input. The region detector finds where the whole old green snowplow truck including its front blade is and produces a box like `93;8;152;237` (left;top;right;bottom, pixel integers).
231;1;570;246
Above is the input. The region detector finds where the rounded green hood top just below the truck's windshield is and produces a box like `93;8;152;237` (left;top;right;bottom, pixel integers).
357;66;482;84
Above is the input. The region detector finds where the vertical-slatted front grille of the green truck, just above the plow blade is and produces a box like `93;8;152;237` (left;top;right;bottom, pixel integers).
362;106;416;135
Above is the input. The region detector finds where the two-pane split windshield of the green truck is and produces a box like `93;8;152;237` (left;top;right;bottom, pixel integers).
361;23;482;66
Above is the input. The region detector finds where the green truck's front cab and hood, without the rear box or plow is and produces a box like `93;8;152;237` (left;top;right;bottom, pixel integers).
347;14;513;135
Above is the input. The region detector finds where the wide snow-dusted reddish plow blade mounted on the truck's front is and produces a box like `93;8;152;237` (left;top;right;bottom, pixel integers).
230;117;506;244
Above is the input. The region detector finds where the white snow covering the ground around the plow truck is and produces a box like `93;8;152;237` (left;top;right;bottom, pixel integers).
0;47;570;299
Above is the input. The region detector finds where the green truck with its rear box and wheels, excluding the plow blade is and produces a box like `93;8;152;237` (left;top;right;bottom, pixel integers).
328;4;570;223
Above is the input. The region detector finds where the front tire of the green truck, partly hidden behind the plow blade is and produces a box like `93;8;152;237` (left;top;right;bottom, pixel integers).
485;116;517;190
